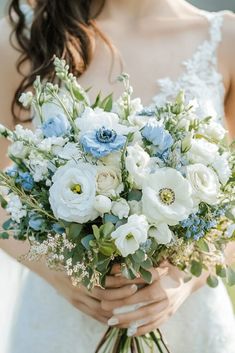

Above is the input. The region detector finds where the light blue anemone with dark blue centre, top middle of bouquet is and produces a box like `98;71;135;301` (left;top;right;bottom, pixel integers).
80;127;126;158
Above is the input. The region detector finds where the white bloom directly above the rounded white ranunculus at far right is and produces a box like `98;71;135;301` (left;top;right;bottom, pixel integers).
188;139;218;165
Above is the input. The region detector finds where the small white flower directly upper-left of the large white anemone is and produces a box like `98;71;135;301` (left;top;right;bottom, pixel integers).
126;144;150;189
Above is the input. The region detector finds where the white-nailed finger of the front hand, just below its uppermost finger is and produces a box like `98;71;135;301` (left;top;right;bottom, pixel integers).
108;300;168;327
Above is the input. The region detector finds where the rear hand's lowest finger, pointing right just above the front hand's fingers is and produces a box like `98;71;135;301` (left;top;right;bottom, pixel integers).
92;284;138;301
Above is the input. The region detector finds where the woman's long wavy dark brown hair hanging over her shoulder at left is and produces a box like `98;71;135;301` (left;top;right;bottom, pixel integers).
9;0;110;118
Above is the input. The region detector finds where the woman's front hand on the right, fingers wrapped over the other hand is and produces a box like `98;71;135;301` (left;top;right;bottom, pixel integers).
101;264;203;336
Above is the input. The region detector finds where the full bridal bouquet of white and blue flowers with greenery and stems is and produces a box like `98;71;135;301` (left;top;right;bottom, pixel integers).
0;58;235;353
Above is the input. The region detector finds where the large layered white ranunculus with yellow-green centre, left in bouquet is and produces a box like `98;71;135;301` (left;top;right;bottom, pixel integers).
49;161;98;223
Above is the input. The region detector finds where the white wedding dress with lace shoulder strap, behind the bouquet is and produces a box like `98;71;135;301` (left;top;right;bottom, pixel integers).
0;12;235;353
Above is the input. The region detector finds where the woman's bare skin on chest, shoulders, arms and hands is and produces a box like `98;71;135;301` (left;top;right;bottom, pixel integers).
0;0;235;335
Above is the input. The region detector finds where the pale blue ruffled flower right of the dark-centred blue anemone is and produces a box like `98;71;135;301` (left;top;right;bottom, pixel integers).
142;122;174;156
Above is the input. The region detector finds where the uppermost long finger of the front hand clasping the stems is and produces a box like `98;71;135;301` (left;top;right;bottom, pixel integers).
102;281;166;314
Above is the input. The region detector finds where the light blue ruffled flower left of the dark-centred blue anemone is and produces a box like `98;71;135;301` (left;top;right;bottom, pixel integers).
42;114;70;137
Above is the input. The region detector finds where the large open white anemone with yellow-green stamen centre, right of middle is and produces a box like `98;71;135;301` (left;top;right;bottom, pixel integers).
142;168;194;225
